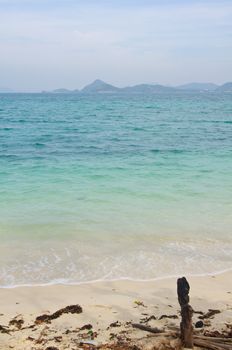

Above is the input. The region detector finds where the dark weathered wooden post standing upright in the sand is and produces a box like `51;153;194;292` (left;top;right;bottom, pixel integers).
177;277;193;349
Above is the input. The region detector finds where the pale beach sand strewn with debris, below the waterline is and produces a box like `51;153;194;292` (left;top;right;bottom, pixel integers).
0;271;232;350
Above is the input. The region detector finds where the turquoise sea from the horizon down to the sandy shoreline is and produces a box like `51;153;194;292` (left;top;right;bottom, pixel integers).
0;94;232;286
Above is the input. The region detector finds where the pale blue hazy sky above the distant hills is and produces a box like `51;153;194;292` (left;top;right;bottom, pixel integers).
0;0;232;92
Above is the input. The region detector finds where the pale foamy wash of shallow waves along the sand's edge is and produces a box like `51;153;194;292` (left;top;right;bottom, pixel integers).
0;239;232;287
